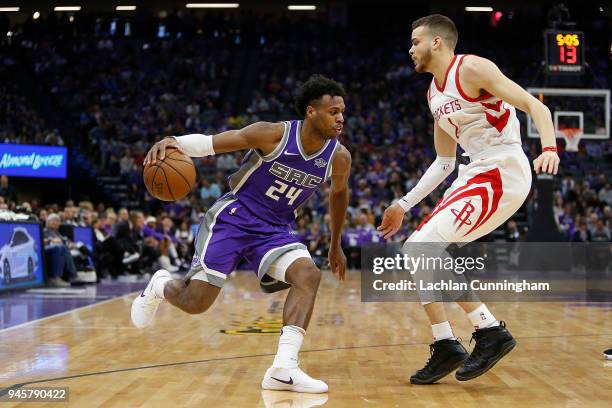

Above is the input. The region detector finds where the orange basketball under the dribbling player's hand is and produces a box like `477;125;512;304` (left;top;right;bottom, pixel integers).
142;149;196;201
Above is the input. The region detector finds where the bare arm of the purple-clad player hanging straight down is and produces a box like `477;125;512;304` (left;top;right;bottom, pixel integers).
328;145;351;281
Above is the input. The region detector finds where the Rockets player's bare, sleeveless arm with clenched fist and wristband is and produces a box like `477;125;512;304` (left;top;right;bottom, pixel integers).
459;55;559;174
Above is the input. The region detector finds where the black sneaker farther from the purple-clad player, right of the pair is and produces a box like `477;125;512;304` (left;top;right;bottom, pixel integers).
455;322;516;381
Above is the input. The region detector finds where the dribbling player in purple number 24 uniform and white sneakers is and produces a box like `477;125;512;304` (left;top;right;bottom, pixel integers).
132;75;351;393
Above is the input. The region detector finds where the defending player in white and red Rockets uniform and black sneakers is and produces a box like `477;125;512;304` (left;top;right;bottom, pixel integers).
378;14;559;384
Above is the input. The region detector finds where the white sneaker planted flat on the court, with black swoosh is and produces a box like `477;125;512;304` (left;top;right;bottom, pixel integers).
261;367;328;394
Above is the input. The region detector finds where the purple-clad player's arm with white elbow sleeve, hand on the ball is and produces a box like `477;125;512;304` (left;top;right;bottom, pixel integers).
144;122;285;165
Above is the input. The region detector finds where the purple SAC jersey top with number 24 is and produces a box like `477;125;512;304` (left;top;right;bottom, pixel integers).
229;120;340;224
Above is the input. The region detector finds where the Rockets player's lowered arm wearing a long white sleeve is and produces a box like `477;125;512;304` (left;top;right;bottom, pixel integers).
378;122;457;239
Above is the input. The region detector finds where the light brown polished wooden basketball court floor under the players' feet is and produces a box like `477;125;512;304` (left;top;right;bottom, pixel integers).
0;273;612;408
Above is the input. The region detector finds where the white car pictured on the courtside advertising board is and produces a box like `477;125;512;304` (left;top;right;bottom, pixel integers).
0;227;38;285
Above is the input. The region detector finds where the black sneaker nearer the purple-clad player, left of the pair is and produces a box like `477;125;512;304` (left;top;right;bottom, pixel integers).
410;339;469;384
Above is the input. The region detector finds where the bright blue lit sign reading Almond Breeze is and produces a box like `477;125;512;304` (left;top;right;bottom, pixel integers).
0;143;68;178
